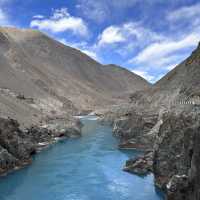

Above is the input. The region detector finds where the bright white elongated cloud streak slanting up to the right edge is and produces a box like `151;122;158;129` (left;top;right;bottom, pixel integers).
129;33;200;67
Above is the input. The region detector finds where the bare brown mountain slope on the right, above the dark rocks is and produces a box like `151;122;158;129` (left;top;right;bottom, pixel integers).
131;42;200;110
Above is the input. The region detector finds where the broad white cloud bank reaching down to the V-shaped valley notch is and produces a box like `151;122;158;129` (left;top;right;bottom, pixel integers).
129;33;200;83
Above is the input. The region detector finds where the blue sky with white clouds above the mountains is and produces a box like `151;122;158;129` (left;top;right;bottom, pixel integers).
0;0;200;83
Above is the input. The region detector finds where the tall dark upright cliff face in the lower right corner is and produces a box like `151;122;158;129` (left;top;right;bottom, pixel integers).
153;113;200;200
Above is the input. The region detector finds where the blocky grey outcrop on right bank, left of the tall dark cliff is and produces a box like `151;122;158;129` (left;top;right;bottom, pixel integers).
113;112;158;149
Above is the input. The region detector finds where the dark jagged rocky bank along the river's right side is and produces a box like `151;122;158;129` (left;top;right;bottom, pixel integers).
107;110;200;200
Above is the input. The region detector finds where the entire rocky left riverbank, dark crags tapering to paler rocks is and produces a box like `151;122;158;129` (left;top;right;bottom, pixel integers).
0;118;82;175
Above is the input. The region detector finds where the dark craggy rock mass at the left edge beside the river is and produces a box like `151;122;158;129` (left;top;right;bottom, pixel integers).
0;118;36;174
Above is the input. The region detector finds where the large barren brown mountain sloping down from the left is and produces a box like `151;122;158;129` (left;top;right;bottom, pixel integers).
0;28;150;123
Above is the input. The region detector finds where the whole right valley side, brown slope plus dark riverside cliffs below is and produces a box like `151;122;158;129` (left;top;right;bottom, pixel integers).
106;41;200;200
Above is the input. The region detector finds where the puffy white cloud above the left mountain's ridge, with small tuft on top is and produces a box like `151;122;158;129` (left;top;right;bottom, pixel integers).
30;8;88;36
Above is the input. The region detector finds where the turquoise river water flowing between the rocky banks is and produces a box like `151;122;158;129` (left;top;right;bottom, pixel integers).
0;117;163;200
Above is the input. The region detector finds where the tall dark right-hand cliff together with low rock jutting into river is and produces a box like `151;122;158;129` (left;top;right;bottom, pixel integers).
124;111;200;200
